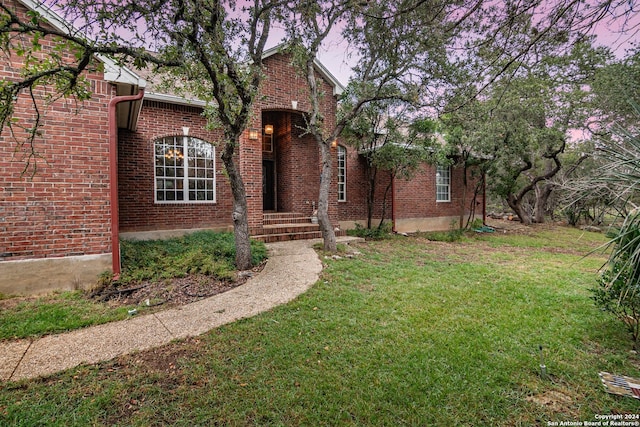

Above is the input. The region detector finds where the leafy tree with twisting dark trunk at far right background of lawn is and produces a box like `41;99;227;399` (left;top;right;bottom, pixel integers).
446;41;608;224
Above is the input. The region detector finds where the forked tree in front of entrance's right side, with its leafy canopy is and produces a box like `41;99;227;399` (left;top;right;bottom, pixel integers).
286;0;482;251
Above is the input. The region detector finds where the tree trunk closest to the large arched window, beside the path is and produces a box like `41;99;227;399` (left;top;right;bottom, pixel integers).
222;137;252;270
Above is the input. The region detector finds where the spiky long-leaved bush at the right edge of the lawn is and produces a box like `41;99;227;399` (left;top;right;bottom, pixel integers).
593;211;640;348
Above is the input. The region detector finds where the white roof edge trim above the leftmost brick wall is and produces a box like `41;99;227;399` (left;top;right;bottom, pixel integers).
18;0;147;88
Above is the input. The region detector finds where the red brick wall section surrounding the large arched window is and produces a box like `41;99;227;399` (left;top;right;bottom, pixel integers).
118;101;233;232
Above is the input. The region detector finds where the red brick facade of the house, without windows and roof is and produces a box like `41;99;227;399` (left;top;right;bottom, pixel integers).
0;0;484;293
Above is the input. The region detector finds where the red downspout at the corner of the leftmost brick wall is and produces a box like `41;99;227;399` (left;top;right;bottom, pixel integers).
109;88;144;281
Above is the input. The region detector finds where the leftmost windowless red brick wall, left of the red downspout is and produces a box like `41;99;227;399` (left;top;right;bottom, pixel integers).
0;1;114;260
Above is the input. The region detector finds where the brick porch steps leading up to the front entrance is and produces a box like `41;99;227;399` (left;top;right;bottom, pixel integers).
251;212;346;243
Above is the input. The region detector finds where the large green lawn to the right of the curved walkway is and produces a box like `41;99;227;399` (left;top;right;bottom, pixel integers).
0;228;640;426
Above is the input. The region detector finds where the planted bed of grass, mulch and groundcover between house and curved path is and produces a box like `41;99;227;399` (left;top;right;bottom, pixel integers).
0;231;266;340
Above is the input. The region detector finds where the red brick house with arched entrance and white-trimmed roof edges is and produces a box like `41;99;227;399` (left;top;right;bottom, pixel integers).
0;0;484;294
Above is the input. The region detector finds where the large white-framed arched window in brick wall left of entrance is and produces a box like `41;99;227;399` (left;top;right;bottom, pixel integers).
155;136;216;203
